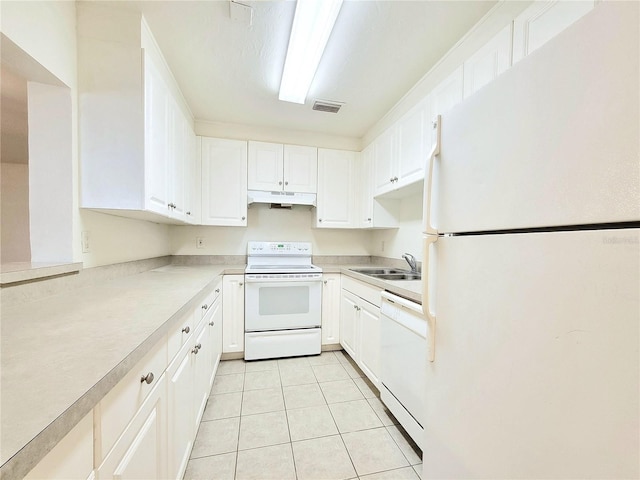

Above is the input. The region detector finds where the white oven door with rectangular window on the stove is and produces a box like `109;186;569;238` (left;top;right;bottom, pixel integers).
245;275;322;332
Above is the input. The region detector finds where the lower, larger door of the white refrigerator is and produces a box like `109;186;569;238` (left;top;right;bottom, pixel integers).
422;229;640;479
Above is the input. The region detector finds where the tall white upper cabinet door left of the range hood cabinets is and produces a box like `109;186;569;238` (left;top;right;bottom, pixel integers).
201;137;247;227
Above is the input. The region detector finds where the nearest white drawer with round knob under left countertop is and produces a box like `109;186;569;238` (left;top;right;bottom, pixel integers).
96;338;167;460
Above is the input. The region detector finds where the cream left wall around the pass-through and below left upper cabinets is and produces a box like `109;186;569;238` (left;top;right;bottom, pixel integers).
0;0;171;268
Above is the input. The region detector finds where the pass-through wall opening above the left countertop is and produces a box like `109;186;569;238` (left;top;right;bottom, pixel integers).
0;34;73;265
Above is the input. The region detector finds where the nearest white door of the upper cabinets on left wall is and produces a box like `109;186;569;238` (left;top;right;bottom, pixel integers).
144;56;170;216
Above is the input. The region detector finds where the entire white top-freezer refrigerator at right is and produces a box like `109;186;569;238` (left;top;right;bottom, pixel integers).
422;2;640;479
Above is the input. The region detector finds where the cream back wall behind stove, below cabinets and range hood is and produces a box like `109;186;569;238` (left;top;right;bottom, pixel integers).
171;205;370;255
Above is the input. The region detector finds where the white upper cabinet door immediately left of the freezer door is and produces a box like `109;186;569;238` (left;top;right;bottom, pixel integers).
394;101;430;188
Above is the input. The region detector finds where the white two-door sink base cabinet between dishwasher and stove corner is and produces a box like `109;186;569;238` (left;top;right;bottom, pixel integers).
340;276;382;388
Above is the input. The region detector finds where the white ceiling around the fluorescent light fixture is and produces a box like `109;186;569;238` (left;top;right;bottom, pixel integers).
132;0;496;138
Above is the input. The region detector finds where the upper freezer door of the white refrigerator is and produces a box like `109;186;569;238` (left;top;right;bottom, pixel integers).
425;2;640;233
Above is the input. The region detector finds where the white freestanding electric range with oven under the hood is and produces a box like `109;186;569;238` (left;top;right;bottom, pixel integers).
244;242;322;360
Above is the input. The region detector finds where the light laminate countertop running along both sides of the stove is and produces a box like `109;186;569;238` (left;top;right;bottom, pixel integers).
0;265;421;478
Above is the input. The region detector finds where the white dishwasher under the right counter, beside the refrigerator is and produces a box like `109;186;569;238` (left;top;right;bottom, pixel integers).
380;292;428;449
